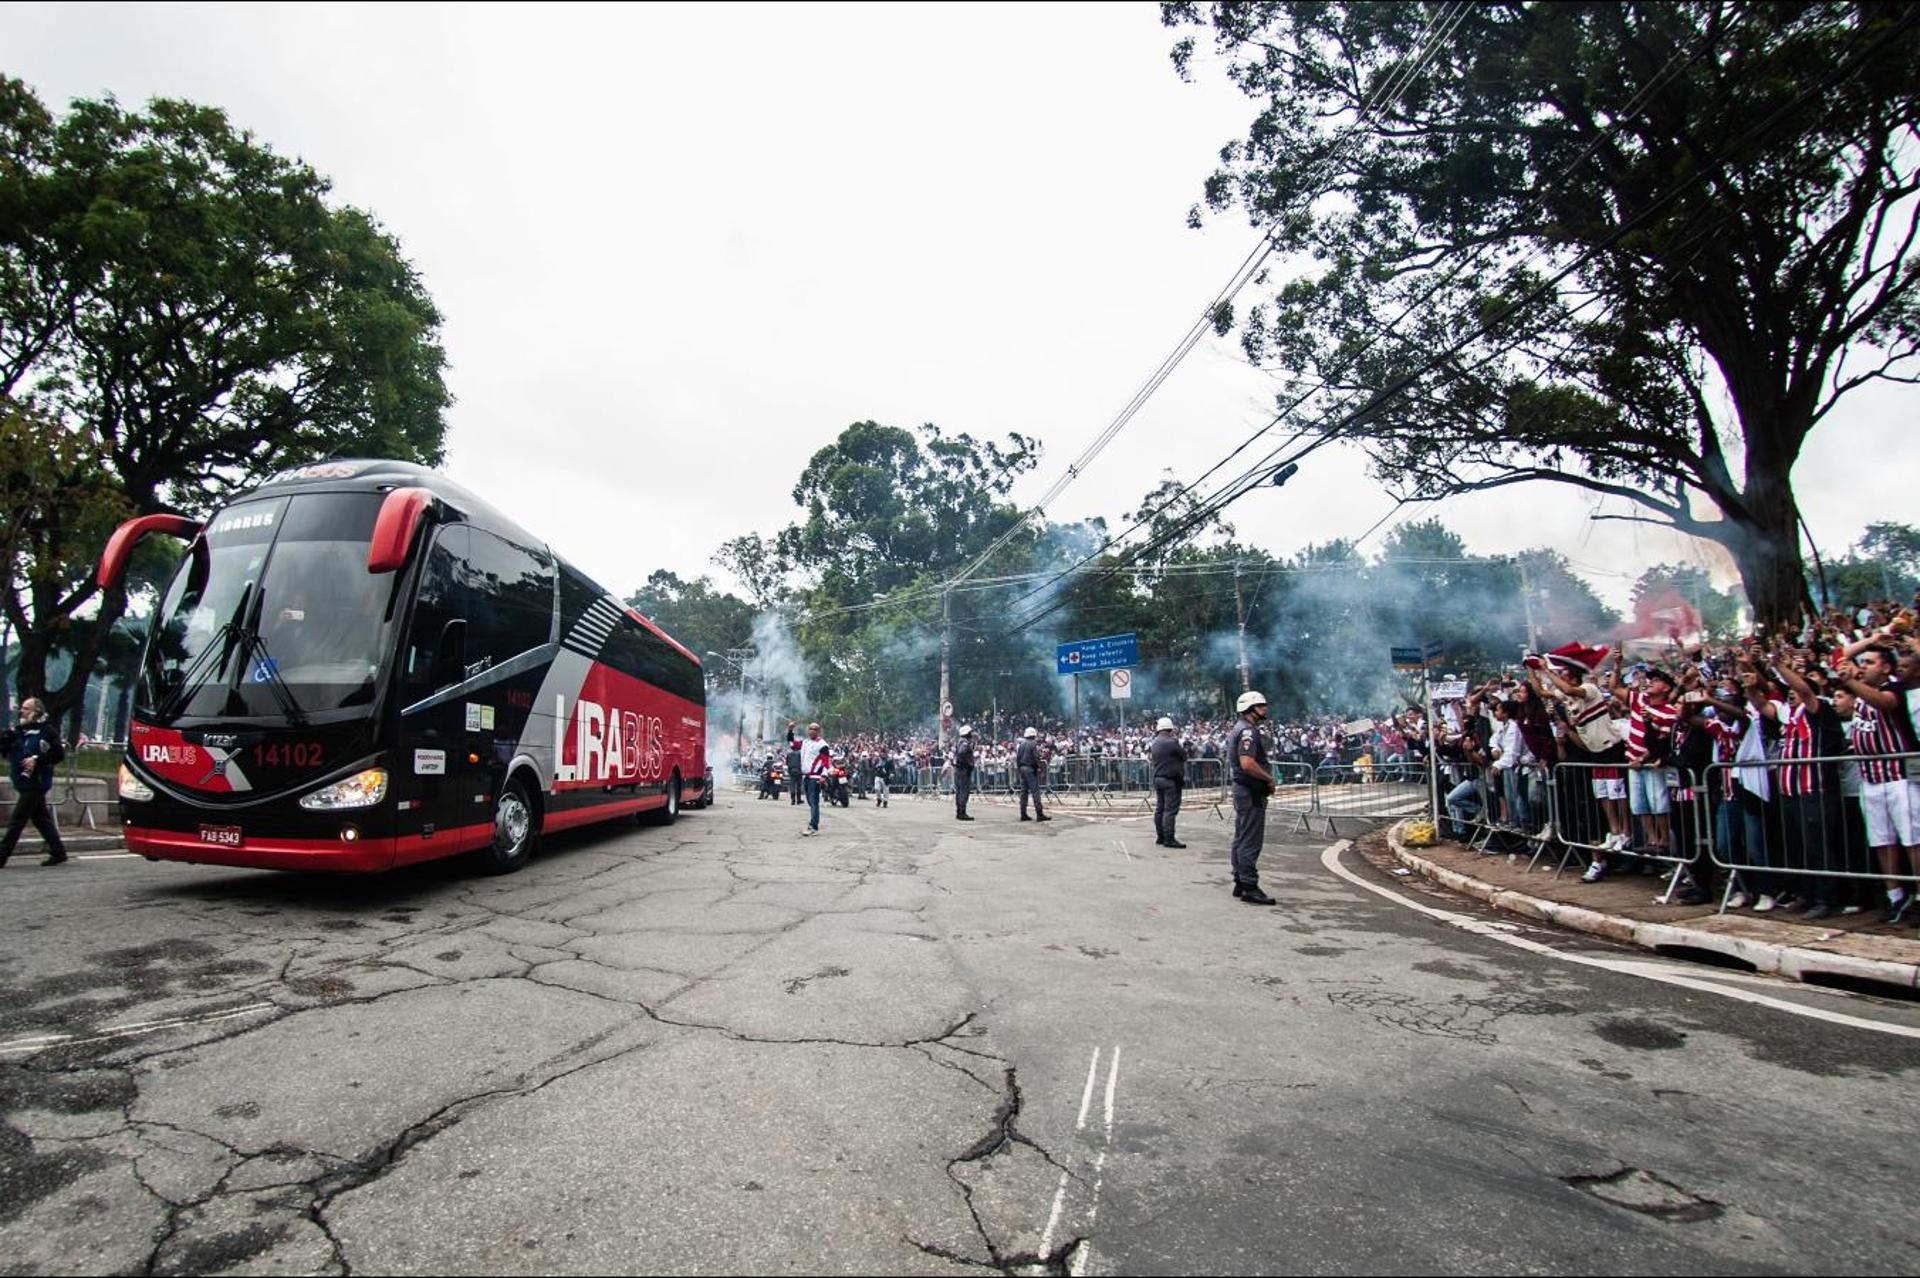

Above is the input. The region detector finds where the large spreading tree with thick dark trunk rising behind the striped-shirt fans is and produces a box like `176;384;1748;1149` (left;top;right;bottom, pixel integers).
1164;0;1920;622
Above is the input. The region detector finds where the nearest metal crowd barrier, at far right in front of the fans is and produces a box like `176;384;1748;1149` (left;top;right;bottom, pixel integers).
1690;754;1920;911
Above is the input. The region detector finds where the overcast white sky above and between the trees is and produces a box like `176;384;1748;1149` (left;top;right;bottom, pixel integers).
0;4;1916;603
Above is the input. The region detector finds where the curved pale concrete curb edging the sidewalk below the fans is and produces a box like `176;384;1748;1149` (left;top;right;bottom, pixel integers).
1386;821;1920;990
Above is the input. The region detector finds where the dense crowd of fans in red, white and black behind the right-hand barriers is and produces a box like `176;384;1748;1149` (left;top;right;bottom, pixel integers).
1434;595;1920;923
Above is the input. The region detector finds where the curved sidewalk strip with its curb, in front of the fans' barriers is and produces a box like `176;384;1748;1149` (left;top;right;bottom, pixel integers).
1380;825;1920;992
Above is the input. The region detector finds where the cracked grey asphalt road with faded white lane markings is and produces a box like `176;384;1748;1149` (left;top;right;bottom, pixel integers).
0;782;1920;1274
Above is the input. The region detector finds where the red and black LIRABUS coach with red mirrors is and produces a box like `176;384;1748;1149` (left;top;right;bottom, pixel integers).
98;461;710;871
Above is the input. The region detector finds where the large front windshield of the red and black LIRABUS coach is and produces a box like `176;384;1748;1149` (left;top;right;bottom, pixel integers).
140;493;401;722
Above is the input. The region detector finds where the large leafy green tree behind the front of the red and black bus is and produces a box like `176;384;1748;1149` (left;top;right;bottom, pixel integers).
0;77;449;712
